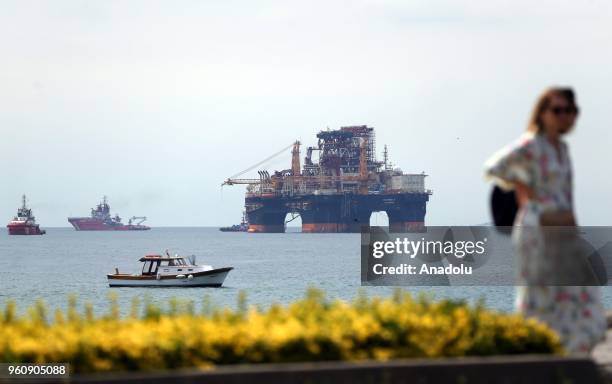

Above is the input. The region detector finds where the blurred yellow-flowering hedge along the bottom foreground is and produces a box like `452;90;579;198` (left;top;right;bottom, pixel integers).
0;289;562;372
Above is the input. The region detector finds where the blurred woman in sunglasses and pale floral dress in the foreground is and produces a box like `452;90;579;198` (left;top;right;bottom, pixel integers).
486;88;606;354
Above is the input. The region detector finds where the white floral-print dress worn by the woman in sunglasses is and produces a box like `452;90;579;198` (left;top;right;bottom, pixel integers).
486;133;606;354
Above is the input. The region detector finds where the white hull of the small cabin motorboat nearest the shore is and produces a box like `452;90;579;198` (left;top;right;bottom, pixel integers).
107;267;233;288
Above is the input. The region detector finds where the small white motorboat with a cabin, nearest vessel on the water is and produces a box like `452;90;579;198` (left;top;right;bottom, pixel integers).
106;251;234;288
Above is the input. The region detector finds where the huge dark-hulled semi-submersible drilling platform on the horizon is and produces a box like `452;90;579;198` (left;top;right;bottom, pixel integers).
223;125;432;233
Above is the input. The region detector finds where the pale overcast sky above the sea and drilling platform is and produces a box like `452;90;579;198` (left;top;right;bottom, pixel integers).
0;0;612;227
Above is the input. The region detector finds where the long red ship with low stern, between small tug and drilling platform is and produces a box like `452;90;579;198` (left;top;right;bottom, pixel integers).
68;196;151;231
